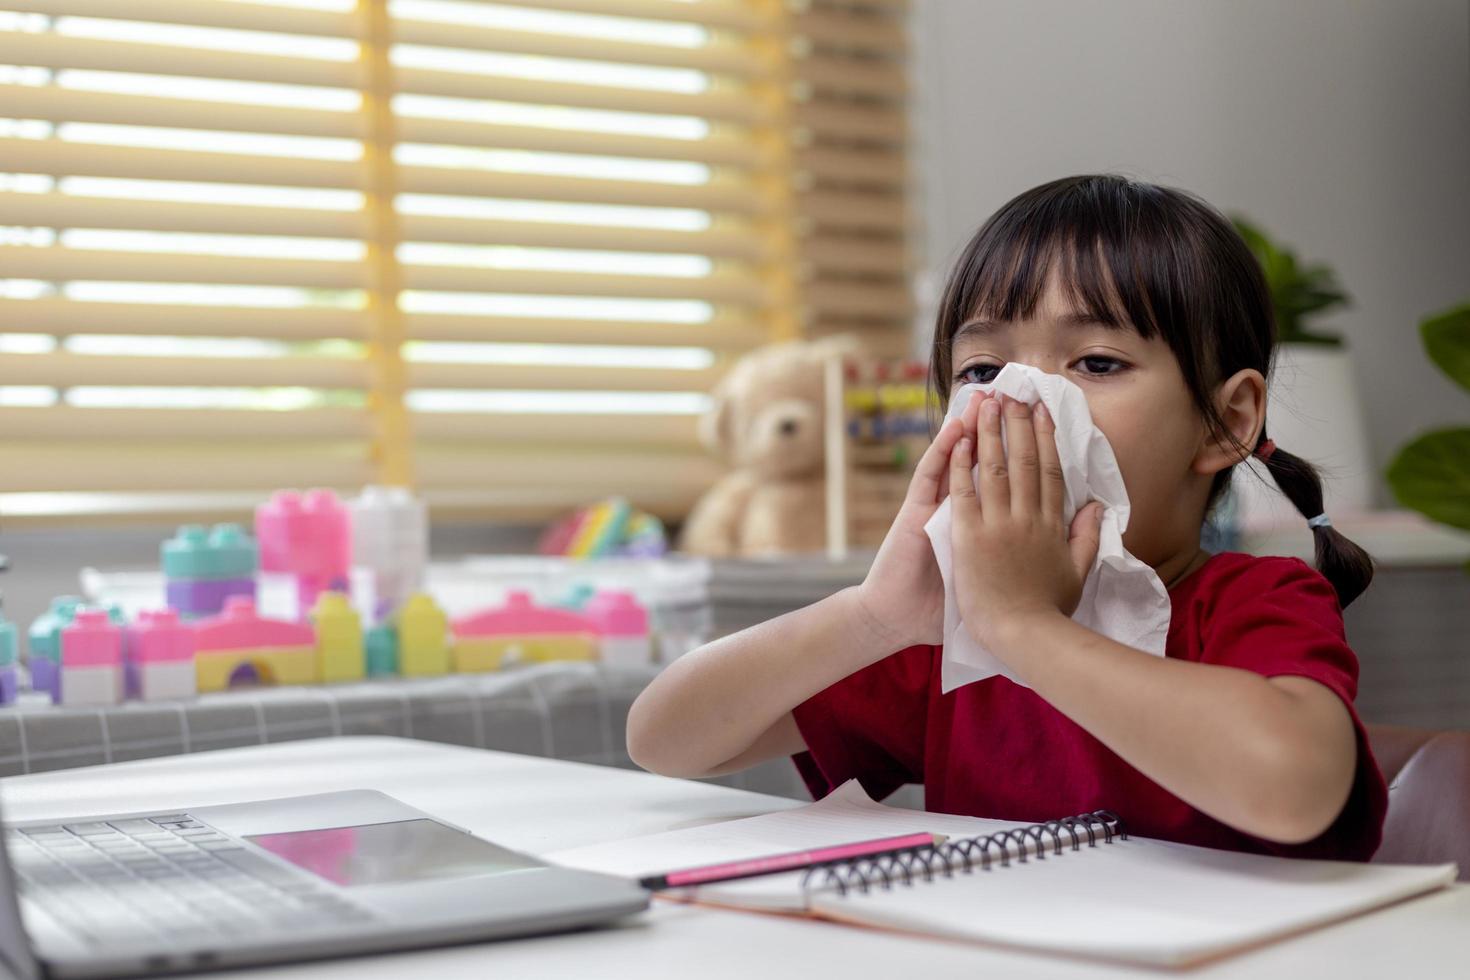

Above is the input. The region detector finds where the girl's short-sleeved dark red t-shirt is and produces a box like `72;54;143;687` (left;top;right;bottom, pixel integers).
794;552;1388;861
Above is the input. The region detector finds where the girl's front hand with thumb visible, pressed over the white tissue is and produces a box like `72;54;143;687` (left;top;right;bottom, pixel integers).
950;395;1103;654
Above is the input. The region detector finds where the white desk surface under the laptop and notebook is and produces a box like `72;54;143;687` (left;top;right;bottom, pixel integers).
0;738;1470;980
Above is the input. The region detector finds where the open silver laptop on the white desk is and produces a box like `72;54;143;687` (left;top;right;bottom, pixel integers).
0;790;648;980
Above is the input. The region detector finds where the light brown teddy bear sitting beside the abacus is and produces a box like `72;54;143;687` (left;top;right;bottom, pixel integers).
681;335;861;557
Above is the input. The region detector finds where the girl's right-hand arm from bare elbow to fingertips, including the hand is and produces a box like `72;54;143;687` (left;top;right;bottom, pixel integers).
950;398;1357;843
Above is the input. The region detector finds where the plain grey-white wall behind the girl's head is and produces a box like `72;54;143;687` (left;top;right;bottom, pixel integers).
914;0;1470;502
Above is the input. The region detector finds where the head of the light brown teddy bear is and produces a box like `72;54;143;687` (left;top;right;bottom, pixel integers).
700;336;860;480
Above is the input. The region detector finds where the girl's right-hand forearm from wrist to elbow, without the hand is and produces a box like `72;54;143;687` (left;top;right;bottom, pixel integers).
989;611;1357;843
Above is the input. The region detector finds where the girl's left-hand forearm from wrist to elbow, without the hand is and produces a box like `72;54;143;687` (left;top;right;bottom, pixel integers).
628;586;897;777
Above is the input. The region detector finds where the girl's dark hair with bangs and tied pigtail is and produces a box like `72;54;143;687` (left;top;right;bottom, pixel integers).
931;175;1373;607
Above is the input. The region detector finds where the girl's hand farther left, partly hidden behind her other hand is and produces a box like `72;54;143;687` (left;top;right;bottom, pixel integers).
857;398;979;651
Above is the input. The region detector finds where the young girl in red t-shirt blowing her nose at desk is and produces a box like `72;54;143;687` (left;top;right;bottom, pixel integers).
628;176;1388;860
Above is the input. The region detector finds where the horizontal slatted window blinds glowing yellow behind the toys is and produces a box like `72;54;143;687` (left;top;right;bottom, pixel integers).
0;0;910;520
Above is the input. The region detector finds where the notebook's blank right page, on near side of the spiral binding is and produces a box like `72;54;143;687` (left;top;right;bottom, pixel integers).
810;837;1455;965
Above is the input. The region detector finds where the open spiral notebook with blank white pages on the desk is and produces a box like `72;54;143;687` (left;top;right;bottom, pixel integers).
548;782;1457;967
